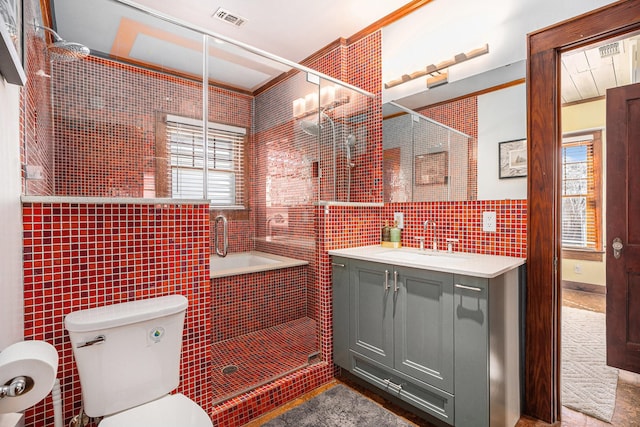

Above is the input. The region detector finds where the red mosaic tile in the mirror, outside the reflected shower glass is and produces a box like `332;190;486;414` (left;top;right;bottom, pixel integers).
416;96;478;200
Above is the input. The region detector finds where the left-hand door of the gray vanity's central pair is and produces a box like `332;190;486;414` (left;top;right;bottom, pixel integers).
349;260;394;367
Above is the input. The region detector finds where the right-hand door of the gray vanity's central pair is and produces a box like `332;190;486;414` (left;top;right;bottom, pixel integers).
394;267;454;394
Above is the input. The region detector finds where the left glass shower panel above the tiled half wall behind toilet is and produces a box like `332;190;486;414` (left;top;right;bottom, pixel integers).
44;0;204;199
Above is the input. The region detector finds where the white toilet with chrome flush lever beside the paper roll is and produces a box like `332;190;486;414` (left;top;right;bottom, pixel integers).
64;295;213;427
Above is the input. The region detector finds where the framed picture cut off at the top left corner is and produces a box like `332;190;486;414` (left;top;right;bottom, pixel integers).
0;0;27;86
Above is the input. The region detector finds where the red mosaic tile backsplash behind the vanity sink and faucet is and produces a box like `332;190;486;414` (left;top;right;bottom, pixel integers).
321;200;527;258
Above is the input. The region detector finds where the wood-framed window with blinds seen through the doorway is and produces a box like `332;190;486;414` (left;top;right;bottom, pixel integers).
562;133;602;250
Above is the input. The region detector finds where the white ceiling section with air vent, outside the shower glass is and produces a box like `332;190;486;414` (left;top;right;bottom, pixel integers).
129;0;411;62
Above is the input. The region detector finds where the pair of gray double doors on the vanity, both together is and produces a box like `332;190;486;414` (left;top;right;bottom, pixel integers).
350;261;453;393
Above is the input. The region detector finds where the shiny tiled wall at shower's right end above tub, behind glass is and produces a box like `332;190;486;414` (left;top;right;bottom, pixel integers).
253;72;323;244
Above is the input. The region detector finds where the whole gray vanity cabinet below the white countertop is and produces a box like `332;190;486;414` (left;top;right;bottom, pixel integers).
332;255;520;427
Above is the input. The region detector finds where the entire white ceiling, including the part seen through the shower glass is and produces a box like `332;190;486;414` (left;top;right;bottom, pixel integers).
51;0;411;91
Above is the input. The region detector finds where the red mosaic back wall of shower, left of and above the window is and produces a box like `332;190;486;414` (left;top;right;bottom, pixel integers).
47;57;252;197
